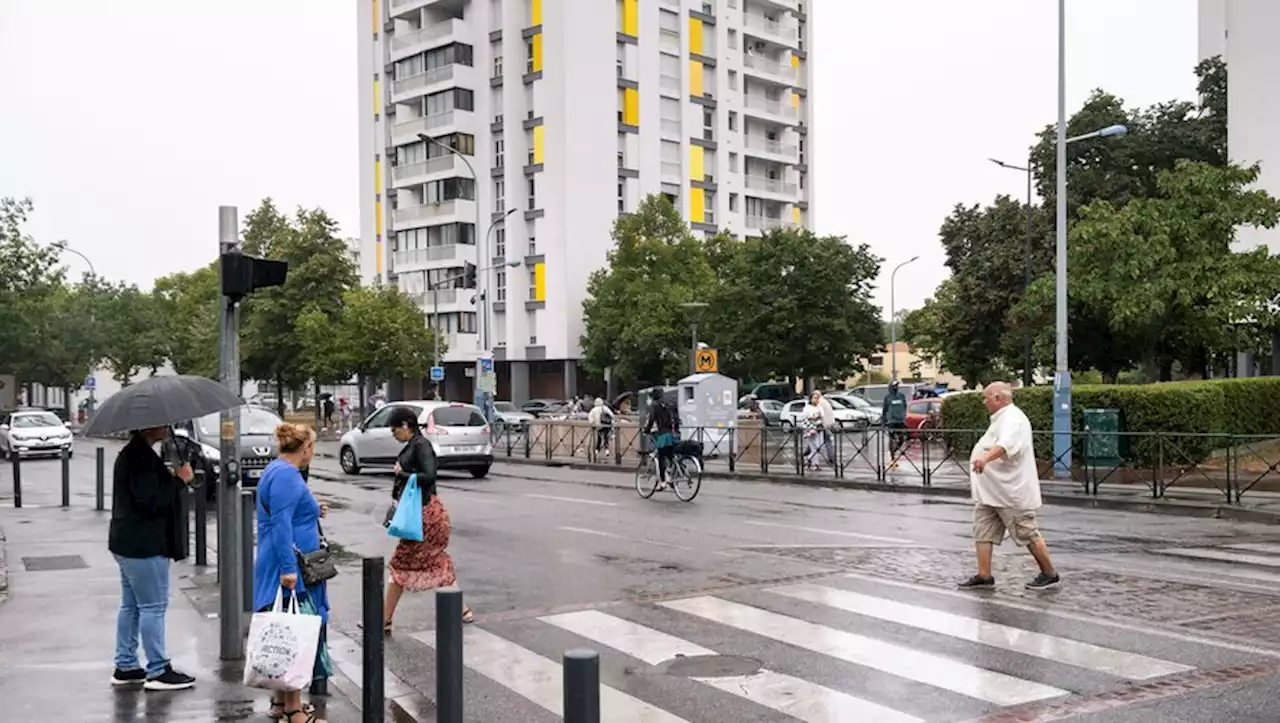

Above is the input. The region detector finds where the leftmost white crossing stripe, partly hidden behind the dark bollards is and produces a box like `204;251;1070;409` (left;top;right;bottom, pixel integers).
412;627;687;723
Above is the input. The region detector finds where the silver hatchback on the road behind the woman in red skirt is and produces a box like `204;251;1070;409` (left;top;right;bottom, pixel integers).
338;401;493;479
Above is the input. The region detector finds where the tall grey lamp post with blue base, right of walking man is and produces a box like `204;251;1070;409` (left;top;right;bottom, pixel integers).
1053;0;1071;477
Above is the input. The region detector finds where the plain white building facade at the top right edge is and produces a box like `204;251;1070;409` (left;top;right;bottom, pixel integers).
1199;0;1280;252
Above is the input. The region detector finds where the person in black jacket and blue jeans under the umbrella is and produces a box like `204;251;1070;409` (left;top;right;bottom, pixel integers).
108;427;196;691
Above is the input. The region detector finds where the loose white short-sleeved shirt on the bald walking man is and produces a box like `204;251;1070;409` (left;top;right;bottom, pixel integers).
969;404;1041;511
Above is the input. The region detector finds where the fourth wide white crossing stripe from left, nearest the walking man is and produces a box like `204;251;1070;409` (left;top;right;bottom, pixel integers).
769;585;1193;681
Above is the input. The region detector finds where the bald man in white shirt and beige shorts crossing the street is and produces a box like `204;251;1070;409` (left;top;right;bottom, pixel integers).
960;381;1059;590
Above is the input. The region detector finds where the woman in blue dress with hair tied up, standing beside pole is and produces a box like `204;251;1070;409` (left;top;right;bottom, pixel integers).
253;422;333;723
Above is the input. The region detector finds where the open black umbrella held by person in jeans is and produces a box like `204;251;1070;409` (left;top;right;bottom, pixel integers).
84;375;244;436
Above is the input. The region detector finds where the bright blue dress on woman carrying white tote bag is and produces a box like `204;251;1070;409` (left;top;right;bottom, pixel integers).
253;459;329;623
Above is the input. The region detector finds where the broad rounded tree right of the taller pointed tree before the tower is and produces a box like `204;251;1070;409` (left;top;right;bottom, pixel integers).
707;229;884;380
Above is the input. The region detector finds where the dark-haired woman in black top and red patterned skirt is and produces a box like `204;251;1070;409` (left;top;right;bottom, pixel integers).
383;407;475;635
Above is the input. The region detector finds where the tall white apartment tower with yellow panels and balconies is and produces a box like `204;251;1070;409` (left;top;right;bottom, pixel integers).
358;0;814;401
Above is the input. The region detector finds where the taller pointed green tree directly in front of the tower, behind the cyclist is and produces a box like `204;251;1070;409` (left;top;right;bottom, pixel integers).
581;196;714;383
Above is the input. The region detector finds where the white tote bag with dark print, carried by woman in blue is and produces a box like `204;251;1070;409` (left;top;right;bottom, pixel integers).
244;590;321;691
